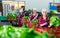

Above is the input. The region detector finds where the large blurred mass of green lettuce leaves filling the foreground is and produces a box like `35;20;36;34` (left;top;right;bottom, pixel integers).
0;25;54;38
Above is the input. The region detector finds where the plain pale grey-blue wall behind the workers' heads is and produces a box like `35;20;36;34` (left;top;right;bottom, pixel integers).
2;0;60;11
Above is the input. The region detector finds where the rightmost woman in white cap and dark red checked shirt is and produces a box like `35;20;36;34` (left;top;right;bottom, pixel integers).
38;9;49;31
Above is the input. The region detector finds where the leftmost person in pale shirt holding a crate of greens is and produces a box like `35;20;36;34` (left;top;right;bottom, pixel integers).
7;5;17;25
